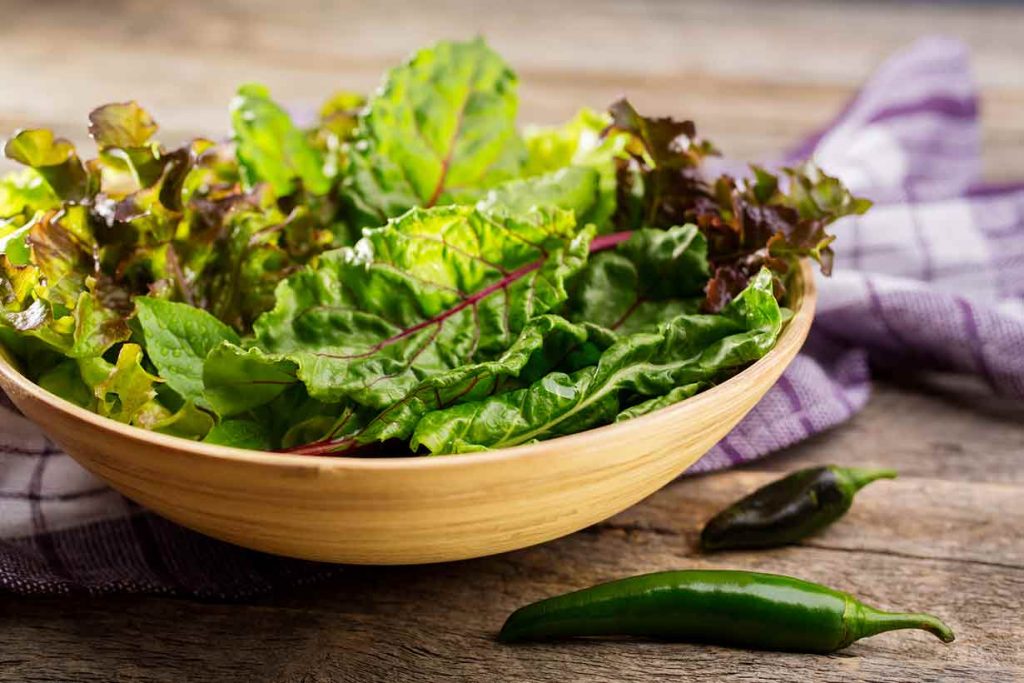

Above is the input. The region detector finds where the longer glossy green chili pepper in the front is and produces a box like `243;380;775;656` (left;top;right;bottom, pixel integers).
498;570;953;652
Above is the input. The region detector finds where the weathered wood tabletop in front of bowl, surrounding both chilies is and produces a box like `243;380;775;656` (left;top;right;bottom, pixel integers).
0;384;1024;683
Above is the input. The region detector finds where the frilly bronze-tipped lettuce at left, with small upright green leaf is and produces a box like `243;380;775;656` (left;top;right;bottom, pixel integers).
0;96;348;357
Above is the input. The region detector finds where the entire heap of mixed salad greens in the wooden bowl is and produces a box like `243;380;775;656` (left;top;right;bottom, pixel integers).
0;40;868;455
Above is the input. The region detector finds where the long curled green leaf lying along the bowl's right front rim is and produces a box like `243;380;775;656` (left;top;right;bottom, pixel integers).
412;270;782;454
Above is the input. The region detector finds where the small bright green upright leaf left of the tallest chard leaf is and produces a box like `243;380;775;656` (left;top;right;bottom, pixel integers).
231;84;331;197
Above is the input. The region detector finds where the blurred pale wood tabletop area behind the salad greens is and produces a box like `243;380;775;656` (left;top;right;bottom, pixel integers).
0;0;1024;178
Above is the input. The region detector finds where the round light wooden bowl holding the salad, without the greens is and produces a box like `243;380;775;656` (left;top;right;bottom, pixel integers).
0;263;816;564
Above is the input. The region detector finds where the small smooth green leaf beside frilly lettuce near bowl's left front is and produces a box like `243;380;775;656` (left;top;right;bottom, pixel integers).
135;297;240;407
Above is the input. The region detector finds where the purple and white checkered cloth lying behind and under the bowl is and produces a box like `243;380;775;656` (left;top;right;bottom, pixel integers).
0;39;1024;599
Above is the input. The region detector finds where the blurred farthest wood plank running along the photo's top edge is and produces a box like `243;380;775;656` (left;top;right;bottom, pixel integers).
4;0;1024;87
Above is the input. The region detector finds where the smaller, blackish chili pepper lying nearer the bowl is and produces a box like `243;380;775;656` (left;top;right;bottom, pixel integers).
700;465;896;550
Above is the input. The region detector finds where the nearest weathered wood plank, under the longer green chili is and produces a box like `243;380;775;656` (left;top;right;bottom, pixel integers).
0;529;1024;681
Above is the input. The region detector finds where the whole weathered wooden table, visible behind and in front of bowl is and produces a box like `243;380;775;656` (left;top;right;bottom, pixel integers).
0;0;1024;683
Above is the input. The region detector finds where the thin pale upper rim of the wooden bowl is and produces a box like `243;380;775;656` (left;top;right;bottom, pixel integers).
0;259;817;471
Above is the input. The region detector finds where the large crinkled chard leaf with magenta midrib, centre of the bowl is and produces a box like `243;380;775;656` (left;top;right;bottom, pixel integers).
255;207;591;409
